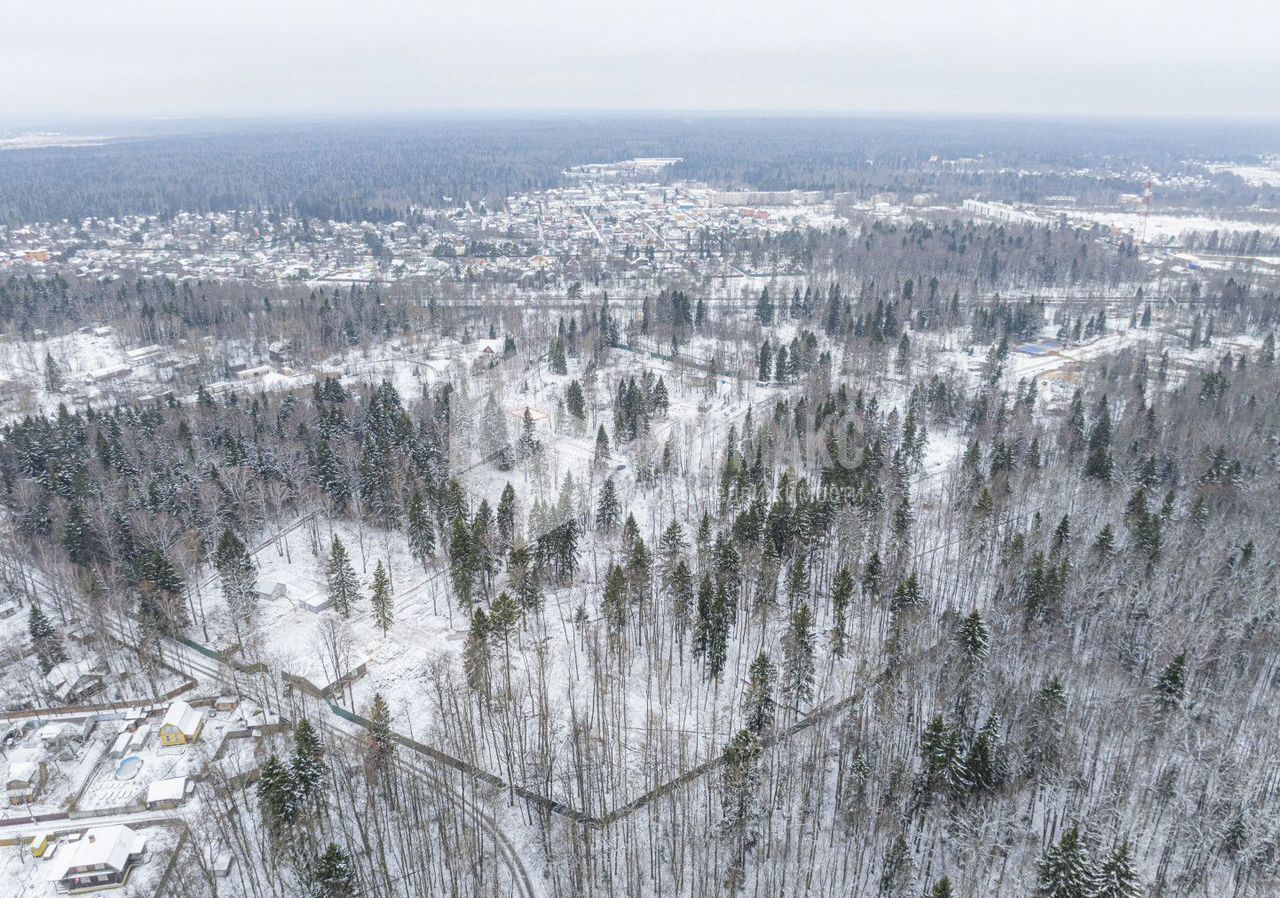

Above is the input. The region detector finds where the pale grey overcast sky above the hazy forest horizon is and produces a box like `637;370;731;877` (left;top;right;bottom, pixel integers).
0;0;1280;120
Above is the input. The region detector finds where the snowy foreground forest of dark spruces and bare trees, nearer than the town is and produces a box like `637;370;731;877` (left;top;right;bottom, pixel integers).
0;119;1280;898
